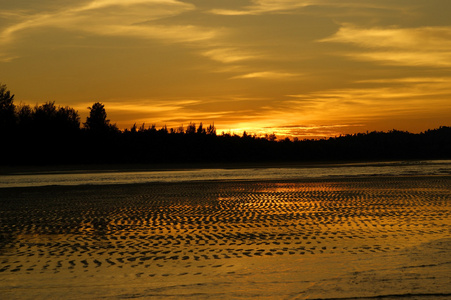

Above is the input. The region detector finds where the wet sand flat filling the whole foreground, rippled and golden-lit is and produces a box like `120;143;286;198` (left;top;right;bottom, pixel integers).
0;177;451;299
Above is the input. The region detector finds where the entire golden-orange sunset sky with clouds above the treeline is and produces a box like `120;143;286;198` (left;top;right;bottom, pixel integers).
0;0;451;139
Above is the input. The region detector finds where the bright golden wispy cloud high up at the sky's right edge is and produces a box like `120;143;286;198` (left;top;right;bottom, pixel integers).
321;24;451;67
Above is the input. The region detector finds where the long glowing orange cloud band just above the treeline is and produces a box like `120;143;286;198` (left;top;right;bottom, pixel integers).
84;72;451;134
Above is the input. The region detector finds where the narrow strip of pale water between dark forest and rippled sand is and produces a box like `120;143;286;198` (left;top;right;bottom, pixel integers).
0;160;451;188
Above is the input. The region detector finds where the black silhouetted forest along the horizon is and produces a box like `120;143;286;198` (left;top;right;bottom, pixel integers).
0;84;451;166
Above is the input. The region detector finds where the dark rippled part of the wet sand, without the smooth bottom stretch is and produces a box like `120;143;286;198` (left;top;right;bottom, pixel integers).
0;177;451;297
